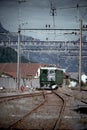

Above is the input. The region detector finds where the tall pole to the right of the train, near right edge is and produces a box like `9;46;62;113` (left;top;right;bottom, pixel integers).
79;20;82;91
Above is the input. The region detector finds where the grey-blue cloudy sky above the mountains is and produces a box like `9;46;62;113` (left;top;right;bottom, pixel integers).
0;0;87;40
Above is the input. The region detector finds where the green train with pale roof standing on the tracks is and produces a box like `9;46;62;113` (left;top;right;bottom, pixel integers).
39;67;64;89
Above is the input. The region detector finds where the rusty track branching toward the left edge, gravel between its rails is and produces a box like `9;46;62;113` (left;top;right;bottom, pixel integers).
0;92;45;130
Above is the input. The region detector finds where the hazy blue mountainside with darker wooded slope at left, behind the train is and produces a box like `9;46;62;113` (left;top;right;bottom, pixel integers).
0;24;87;73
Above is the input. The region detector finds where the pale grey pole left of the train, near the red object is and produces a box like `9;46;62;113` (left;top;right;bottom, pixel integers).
17;25;21;89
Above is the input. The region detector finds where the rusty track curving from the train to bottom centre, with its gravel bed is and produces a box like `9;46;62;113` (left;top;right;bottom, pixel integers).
1;91;65;130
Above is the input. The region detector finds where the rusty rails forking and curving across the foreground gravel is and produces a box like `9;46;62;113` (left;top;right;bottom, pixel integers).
0;90;65;130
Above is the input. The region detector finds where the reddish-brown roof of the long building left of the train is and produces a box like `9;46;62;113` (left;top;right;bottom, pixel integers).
0;63;44;78
